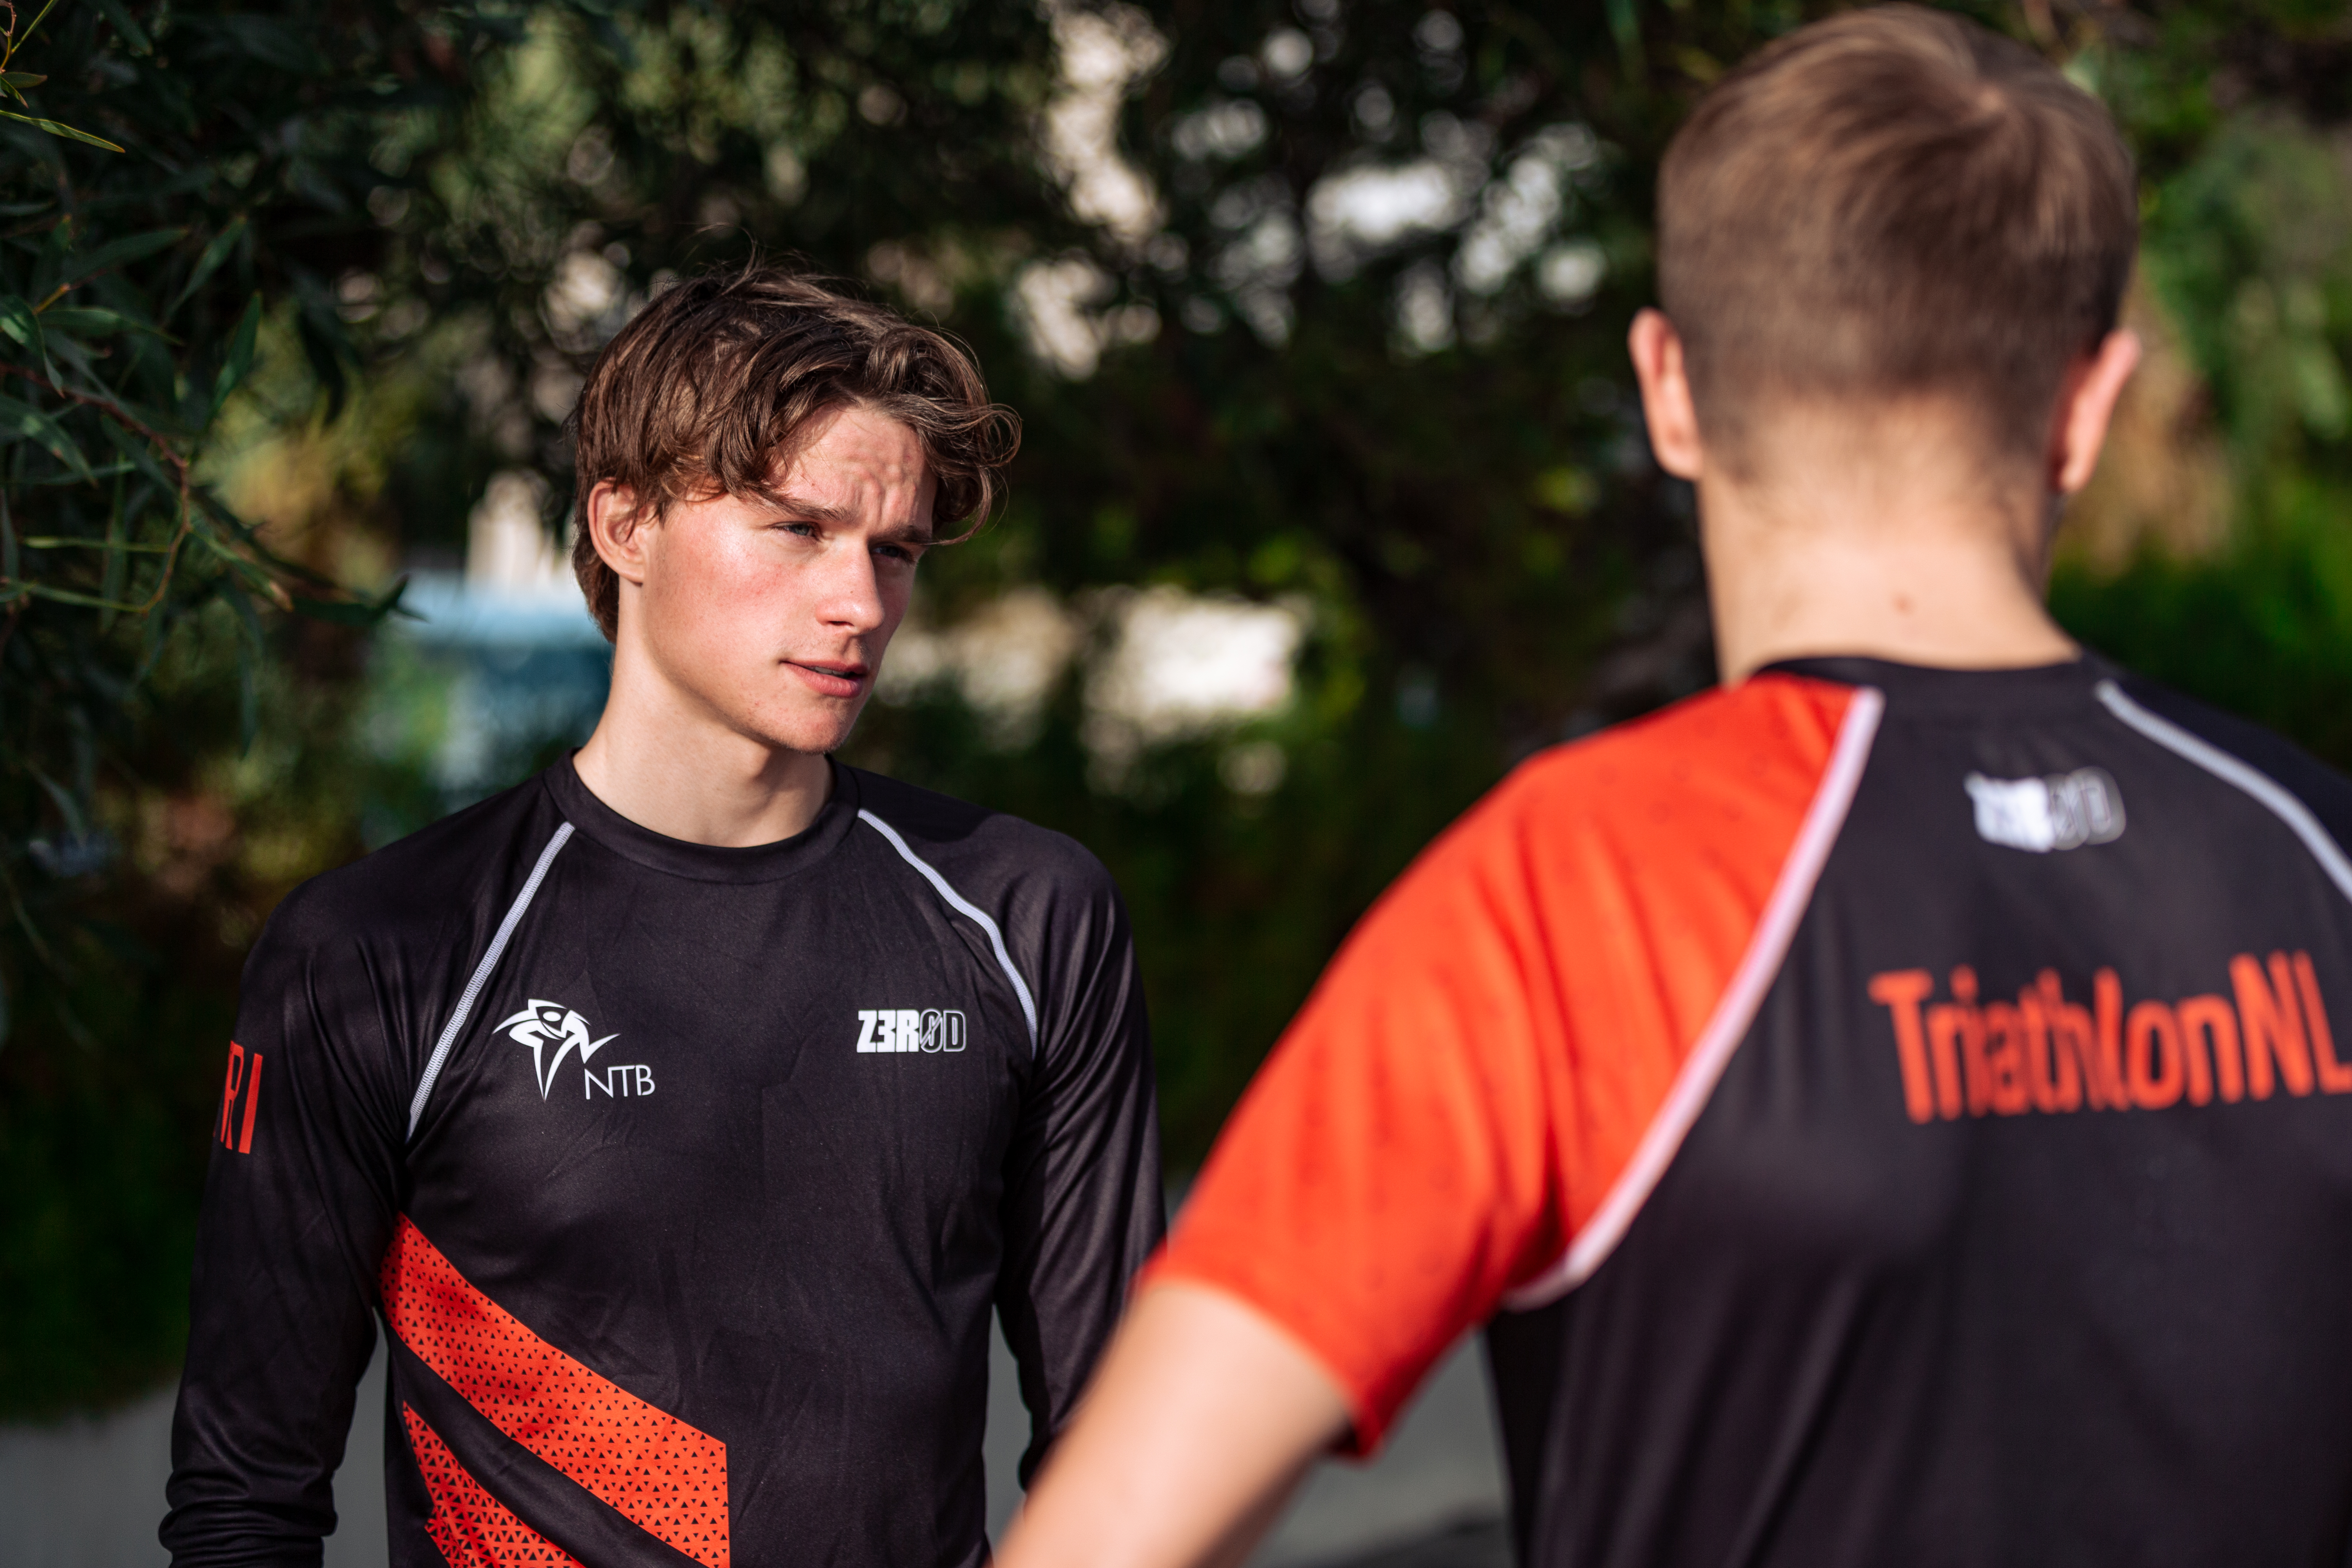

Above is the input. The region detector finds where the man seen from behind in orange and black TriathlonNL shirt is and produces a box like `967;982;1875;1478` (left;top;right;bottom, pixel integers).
1002;10;2352;1568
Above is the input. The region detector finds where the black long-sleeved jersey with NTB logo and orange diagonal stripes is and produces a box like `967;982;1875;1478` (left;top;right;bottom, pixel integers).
162;762;1162;1568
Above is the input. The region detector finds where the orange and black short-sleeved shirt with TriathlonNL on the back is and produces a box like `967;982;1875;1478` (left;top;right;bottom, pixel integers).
1152;658;2352;1568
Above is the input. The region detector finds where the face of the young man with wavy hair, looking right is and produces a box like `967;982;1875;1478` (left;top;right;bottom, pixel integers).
590;404;936;752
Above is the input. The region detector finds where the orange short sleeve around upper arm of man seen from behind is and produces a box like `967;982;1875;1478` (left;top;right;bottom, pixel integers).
1148;808;1564;1453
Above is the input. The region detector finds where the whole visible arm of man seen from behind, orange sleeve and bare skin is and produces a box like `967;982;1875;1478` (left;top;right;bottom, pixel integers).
1004;799;1559;1568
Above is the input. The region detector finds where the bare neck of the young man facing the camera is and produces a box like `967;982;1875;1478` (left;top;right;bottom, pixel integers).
572;656;833;848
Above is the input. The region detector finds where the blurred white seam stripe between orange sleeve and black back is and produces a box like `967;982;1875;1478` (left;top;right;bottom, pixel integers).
1503;686;1886;1312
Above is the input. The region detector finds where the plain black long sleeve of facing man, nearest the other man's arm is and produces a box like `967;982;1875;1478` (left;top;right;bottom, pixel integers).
997;856;1166;1486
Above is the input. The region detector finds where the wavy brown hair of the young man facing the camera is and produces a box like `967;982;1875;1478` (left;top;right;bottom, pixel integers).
569;263;1021;637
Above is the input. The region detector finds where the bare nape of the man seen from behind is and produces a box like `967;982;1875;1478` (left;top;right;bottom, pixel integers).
1698;412;2077;682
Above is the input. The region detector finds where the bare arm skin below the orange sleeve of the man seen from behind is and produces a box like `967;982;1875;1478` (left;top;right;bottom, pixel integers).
997;1284;1348;1568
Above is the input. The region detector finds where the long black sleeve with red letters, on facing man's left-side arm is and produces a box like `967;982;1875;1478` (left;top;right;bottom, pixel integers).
162;891;405;1568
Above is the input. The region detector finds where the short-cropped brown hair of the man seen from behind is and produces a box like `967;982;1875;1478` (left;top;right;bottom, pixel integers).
1658;5;2138;461
